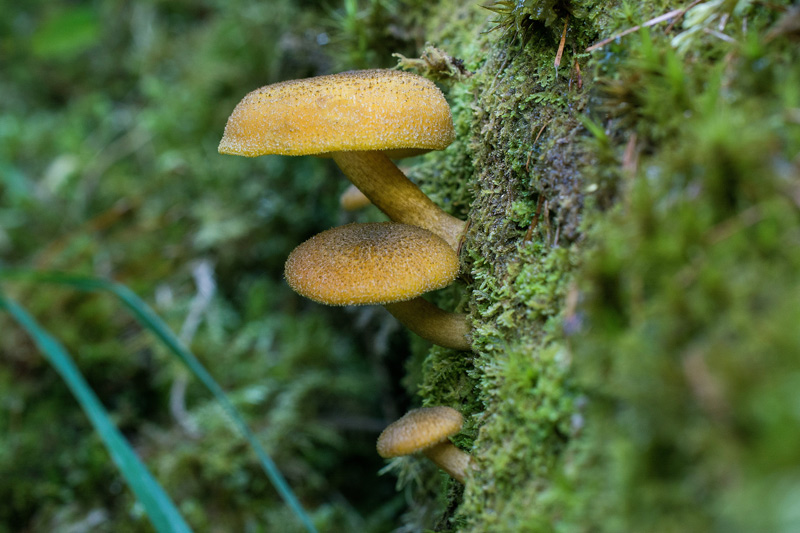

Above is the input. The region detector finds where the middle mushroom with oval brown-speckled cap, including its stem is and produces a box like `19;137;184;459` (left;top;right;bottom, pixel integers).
284;222;471;350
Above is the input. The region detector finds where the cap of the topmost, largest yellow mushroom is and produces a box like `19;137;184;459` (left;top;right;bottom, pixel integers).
219;69;455;157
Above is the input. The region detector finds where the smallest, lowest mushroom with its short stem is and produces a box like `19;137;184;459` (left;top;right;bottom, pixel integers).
376;406;472;483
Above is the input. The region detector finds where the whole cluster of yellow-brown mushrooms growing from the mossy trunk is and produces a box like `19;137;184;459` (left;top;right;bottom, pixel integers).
219;69;471;483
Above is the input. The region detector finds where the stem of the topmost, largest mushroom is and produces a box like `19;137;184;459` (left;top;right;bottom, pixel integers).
331;151;466;250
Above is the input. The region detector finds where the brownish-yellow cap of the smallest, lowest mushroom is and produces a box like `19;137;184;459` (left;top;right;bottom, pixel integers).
377;406;464;459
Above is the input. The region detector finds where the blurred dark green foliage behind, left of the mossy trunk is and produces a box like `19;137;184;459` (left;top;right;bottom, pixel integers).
0;0;432;532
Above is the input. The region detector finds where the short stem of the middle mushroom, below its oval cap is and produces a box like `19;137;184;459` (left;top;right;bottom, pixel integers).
383;296;472;351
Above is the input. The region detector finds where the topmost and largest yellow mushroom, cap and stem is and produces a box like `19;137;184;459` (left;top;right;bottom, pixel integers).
219;69;466;249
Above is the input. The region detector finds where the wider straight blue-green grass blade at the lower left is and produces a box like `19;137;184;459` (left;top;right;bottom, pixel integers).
0;292;191;533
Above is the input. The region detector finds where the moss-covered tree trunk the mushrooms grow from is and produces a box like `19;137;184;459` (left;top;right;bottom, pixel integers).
401;1;800;531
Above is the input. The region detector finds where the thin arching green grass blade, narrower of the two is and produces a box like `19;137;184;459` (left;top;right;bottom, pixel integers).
0;267;317;533
